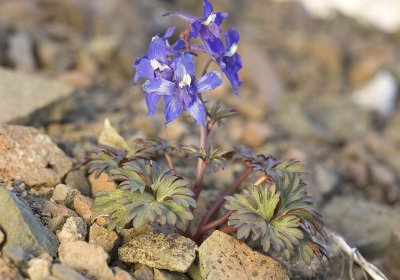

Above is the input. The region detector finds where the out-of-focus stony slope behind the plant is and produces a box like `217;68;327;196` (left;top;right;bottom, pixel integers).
0;0;400;279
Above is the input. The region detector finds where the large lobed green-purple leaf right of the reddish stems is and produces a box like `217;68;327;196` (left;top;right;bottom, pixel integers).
225;173;326;264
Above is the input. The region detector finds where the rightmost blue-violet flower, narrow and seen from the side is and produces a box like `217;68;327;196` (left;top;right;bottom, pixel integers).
217;27;242;94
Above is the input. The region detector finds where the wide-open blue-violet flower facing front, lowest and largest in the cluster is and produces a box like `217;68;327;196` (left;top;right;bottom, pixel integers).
143;53;222;127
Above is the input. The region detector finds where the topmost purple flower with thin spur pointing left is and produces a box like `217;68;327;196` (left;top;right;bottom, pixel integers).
165;0;228;58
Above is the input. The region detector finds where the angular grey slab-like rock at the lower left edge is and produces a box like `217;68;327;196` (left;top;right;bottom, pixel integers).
0;186;58;256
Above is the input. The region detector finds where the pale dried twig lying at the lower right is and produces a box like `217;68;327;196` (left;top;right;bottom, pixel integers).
332;232;388;280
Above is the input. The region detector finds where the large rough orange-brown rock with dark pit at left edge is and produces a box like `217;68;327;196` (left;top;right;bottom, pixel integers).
0;124;72;187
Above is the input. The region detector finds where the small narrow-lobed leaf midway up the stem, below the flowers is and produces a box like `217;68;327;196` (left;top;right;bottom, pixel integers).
181;146;232;172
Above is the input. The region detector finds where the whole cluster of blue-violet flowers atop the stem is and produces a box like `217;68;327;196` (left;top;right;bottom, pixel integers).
134;0;242;127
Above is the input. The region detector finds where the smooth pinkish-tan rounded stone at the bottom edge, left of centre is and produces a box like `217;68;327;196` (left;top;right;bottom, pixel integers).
58;241;114;280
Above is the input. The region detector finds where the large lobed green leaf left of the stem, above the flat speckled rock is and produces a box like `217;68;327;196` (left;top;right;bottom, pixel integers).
93;160;196;230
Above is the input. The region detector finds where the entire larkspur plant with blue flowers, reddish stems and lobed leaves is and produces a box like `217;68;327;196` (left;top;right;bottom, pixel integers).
89;0;326;264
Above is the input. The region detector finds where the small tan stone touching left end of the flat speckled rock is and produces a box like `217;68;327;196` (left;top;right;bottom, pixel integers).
89;224;120;256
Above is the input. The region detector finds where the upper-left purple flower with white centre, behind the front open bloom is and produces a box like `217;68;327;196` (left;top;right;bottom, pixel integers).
133;35;173;83
